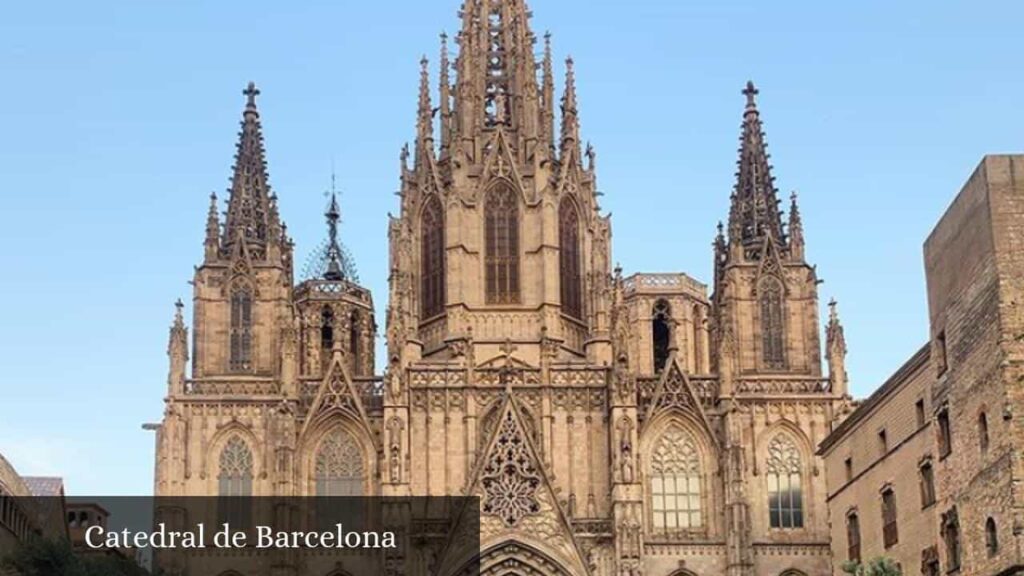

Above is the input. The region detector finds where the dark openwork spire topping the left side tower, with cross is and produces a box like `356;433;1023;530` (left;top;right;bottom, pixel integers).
224;82;271;257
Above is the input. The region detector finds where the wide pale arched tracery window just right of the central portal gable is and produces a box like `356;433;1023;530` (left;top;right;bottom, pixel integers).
650;426;703;532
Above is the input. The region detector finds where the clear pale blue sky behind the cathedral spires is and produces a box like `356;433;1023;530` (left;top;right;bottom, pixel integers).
0;0;1024;494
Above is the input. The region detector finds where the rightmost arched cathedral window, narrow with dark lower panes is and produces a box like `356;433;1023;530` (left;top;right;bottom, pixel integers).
765;434;804;528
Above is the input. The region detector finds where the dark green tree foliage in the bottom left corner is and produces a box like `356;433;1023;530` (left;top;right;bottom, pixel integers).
0;538;150;576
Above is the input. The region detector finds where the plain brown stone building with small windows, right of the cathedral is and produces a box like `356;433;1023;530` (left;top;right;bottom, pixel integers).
821;156;1024;576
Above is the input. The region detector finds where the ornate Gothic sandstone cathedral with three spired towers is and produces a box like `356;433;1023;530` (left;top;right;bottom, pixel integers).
156;0;850;576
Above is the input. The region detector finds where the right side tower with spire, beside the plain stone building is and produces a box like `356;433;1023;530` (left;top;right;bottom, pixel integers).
712;82;821;387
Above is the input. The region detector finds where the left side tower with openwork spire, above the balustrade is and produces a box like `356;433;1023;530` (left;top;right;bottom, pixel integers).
194;82;293;380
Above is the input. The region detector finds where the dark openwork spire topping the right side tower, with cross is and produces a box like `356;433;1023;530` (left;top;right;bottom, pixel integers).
729;82;785;257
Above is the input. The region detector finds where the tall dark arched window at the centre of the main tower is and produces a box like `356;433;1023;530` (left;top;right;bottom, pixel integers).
484;184;519;304
